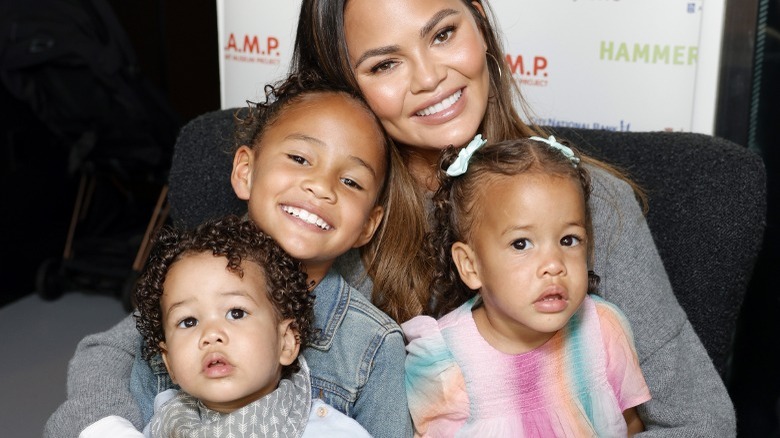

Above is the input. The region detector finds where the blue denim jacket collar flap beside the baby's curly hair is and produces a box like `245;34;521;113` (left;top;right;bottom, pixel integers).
308;270;350;351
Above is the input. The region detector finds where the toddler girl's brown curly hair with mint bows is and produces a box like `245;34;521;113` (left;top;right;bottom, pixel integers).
426;138;599;317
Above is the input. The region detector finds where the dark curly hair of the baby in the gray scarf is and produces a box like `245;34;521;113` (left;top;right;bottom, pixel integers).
134;215;314;377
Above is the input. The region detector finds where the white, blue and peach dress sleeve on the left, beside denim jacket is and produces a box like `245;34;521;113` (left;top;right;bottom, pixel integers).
401;316;469;437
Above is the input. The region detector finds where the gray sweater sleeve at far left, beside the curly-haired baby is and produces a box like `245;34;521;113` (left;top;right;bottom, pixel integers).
44;316;142;438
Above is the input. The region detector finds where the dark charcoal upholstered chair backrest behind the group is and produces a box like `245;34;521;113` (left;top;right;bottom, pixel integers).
168;110;766;378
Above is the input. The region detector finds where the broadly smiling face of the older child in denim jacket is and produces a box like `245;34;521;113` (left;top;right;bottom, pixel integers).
232;92;388;281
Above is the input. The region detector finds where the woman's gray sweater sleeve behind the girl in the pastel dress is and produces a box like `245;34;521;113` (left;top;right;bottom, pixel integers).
590;169;736;438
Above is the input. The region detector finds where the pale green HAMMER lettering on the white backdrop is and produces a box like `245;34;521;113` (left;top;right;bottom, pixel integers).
599;41;699;66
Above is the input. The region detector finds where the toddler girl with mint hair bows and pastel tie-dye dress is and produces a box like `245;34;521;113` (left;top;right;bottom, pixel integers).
402;135;650;437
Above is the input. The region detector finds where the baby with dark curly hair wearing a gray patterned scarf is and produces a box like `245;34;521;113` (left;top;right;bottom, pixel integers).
136;216;368;437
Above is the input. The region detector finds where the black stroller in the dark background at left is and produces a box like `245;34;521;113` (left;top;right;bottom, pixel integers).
0;0;181;309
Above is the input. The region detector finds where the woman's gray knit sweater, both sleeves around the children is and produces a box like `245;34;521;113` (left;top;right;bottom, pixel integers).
44;166;736;438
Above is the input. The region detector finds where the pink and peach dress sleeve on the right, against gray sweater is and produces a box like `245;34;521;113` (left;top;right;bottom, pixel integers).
593;296;651;411
